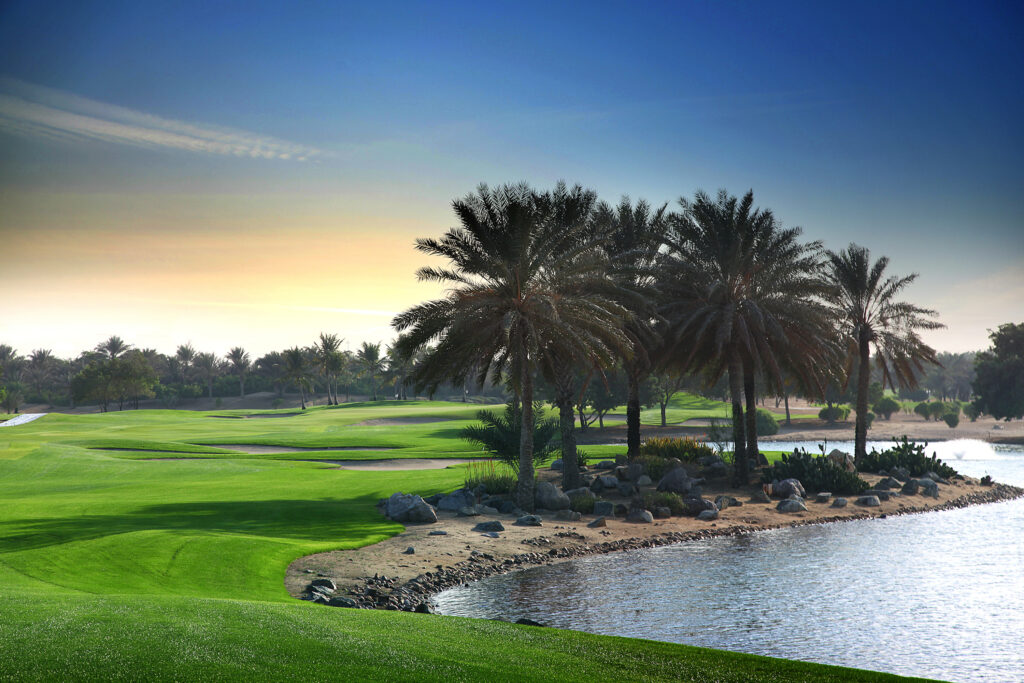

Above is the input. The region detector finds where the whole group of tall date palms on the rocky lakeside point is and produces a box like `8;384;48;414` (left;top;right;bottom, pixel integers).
393;183;940;510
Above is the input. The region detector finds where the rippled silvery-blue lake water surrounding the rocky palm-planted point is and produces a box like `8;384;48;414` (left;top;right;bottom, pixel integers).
434;440;1024;681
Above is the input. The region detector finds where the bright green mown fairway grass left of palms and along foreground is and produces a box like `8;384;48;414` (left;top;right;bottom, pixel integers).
0;402;929;681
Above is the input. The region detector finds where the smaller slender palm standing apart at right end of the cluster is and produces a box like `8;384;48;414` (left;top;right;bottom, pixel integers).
825;244;944;460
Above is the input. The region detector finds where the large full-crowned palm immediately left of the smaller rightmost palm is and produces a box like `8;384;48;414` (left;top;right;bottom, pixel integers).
665;190;830;485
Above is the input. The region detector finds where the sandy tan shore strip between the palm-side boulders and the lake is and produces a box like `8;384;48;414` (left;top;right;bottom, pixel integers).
285;471;1024;610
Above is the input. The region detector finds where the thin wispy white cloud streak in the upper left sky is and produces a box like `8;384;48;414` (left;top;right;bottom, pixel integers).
0;78;325;161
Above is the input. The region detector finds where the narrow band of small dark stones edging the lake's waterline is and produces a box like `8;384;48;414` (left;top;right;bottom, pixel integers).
303;483;1024;612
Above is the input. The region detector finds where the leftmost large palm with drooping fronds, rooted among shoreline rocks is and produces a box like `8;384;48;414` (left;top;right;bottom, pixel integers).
392;183;628;510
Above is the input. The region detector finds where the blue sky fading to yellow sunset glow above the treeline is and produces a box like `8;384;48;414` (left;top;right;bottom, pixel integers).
0;0;1024;357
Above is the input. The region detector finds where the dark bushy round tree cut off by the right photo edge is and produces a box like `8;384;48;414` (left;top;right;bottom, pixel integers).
974;323;1024;421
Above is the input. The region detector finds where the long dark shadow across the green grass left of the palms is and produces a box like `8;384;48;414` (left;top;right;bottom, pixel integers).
0;496;392;553
